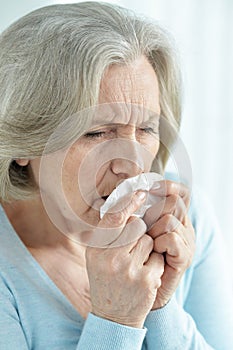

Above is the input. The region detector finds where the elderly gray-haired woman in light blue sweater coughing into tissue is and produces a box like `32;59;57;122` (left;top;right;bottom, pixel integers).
0;2;233;350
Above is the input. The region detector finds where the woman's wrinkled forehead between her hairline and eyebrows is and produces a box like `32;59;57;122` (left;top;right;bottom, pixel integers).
99;56;160;114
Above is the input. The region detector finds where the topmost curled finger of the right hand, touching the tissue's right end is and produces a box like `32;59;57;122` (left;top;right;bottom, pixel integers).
150;180;190;207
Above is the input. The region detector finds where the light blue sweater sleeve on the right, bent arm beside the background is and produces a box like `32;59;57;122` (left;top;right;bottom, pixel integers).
145;190;233;350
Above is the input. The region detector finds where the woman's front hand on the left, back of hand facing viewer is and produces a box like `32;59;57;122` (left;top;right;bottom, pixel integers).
86;191;164;328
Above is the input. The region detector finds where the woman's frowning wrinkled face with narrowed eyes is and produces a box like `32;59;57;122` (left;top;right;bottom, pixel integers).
31;57;160;232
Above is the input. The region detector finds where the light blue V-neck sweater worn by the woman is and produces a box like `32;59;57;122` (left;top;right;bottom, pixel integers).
0;190;233;350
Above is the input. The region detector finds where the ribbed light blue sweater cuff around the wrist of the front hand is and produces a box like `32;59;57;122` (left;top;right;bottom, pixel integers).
77;313;146;350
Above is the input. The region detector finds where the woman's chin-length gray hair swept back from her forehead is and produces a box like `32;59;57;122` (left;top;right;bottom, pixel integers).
0;2;181;201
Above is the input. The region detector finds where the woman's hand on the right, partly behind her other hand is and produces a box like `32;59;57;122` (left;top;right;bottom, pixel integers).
144;181;195;309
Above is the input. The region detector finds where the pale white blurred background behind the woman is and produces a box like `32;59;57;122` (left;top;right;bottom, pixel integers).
0;0;233;270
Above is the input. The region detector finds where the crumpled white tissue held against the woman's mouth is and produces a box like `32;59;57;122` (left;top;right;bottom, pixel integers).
100;173;163;219
